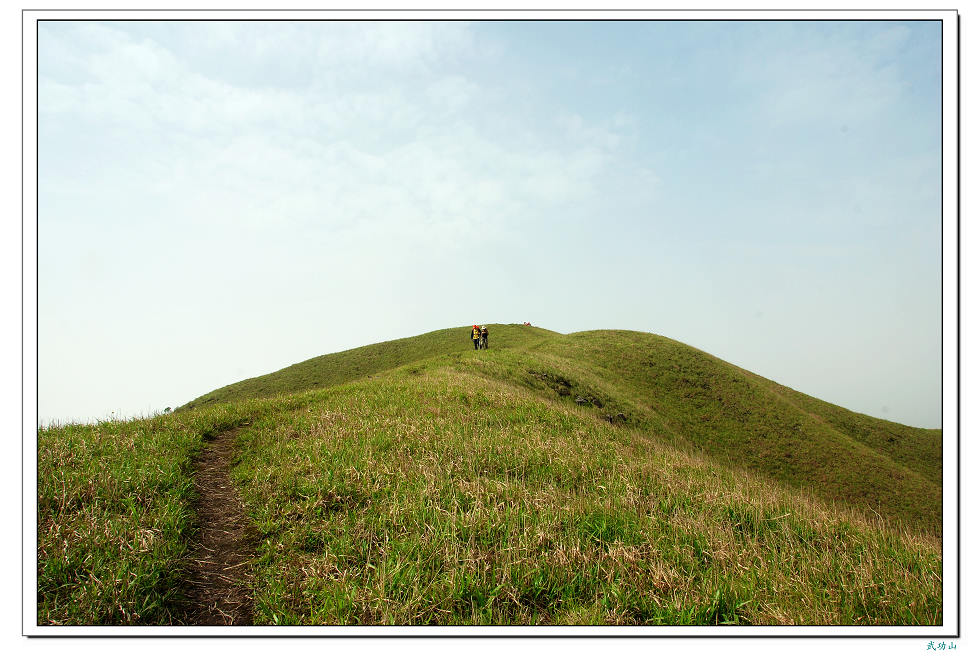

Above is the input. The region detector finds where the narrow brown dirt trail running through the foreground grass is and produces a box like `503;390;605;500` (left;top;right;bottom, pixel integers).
184;428;254;626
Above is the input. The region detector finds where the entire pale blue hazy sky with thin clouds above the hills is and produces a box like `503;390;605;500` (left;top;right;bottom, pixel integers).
38;21;942;427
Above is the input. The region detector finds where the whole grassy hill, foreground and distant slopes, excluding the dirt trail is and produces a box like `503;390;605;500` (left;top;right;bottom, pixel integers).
38;325;942;624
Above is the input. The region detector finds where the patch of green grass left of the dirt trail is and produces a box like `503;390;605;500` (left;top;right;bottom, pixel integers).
37;394;306;625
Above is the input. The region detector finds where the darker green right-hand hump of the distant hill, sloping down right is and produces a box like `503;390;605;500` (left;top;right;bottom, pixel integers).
520;331;942;535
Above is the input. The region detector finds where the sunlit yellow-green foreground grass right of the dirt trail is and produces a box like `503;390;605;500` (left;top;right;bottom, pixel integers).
234;369;941;624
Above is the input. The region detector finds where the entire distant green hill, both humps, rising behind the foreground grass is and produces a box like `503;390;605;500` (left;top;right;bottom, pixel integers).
185;324;942;535
